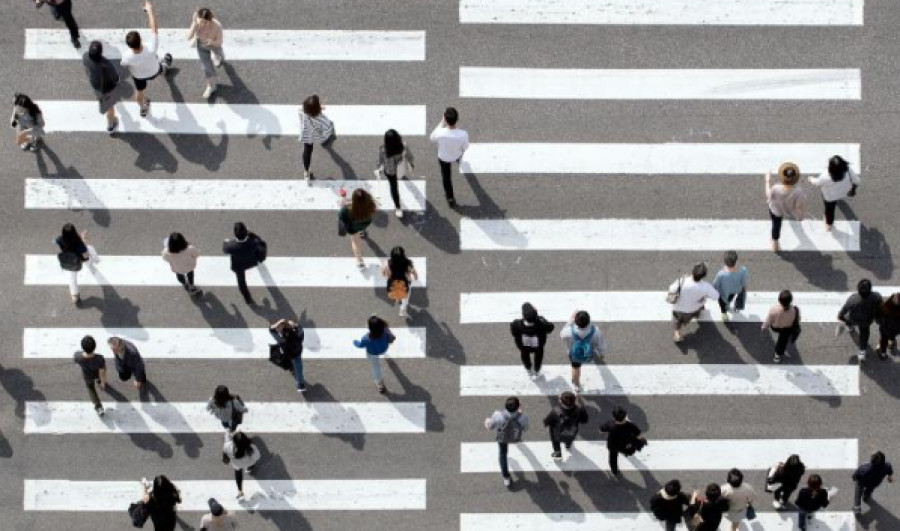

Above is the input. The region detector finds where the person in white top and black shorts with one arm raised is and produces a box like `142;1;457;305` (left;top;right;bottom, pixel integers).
122;0;172;118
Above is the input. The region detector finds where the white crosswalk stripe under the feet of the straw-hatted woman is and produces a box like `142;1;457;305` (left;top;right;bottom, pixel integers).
459;218;860;252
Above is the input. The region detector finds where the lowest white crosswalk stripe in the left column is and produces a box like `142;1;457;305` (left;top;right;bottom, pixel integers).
24;477;426;512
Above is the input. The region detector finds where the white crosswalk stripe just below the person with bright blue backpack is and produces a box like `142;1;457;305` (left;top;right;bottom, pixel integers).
459;364;859;396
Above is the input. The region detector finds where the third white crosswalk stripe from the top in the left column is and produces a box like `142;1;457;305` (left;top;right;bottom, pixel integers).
25;180;425;211
